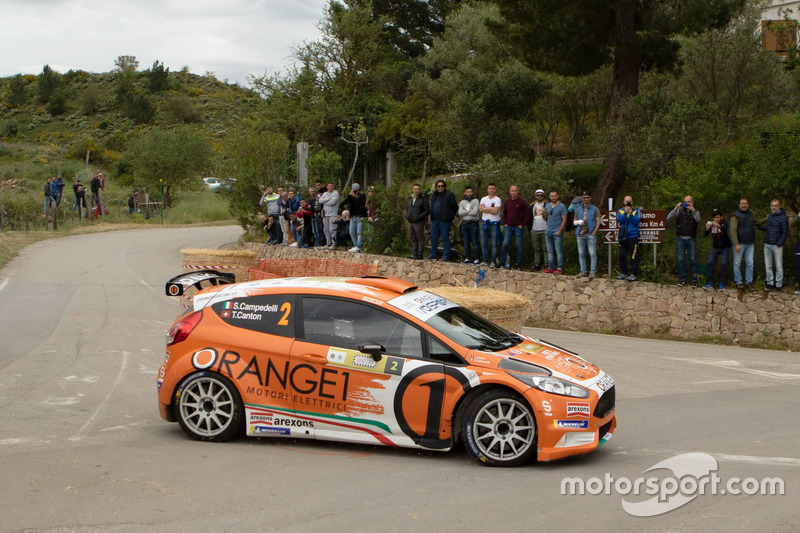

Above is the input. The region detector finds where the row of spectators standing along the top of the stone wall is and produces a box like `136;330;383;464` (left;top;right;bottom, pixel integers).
255;179;800;294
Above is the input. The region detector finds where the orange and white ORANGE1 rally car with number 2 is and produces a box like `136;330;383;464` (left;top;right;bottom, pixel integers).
158;271;616;466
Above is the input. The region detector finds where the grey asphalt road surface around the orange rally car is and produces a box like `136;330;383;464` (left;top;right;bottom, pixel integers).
0;227;800;532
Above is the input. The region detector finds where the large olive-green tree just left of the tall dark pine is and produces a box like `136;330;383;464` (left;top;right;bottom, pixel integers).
406;4;544;167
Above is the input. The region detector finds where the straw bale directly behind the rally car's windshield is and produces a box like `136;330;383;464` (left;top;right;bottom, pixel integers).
425;286;531;333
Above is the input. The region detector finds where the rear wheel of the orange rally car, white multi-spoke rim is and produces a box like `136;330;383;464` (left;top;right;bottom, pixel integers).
173;372;244;442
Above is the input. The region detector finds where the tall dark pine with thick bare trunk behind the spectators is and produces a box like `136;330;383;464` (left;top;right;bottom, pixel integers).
488;0;745;203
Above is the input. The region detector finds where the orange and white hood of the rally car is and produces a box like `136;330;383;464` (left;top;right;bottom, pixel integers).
467;335;602;381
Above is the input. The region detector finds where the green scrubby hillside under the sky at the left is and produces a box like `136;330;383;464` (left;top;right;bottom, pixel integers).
0;69;261;186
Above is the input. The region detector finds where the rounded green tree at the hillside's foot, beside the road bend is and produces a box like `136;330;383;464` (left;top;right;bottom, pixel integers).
127;126;211;206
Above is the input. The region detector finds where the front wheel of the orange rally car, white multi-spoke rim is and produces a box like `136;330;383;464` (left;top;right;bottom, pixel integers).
461;389;536;466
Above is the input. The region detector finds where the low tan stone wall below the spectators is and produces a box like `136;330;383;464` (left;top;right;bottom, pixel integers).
244;244;800;351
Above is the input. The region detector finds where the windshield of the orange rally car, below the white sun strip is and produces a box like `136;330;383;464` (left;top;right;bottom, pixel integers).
427;307;522;352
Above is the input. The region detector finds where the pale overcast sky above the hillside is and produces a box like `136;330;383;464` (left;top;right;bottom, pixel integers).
0;0;328;85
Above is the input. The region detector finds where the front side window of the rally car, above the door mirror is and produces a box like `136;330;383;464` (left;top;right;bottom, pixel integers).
303;296;423;358
